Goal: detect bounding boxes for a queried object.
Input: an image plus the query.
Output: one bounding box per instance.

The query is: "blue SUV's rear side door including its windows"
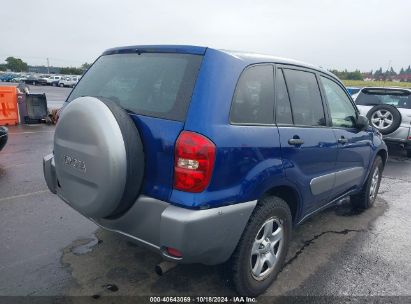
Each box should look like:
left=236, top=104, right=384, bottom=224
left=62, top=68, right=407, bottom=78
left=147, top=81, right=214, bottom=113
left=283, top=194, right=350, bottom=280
left=275, top=66, right=338, bottom=214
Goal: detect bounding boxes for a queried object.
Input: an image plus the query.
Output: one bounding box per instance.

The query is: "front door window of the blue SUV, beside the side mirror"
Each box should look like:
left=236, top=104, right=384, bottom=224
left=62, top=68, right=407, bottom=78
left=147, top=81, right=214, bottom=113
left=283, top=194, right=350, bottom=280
left=321, top=76, right=357, bottom=128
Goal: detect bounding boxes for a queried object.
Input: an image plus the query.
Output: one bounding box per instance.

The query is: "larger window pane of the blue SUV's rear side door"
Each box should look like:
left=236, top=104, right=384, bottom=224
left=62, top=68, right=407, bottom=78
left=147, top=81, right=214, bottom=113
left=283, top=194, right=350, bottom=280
left=284, top=69, right=326, bottom=126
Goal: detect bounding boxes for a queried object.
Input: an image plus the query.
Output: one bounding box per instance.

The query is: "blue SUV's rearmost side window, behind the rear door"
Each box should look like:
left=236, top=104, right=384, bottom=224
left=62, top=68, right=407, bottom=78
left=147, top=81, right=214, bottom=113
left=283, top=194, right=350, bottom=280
left=230, top=65, right=274, bottom=124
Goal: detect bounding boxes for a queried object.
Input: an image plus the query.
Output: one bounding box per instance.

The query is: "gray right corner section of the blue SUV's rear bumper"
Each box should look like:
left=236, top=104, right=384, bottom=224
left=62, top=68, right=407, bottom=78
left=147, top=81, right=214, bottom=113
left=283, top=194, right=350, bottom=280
left=160, top=201, right=257, bottom=265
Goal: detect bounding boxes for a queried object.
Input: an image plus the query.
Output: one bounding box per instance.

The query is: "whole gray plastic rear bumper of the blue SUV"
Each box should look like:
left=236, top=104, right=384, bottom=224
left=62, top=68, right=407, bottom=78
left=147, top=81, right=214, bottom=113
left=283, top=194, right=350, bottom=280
left=43, top=155, right=257, bottom=265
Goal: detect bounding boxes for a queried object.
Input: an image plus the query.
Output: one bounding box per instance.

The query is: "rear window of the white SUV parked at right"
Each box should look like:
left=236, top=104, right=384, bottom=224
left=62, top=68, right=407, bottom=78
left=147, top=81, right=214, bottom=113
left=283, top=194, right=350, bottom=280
left=355, top=89, right=411, bottom=109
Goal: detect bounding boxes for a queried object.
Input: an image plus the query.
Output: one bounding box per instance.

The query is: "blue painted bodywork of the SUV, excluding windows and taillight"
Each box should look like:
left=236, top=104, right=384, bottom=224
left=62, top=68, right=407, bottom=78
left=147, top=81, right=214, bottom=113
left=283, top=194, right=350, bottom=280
left=98, top=46, right=386, bottom=222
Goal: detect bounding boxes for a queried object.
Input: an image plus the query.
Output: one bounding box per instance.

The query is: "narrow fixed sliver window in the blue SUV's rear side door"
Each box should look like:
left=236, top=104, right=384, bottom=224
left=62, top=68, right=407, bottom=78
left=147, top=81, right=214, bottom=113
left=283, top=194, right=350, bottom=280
left=275, top=69, right=293, bottom=125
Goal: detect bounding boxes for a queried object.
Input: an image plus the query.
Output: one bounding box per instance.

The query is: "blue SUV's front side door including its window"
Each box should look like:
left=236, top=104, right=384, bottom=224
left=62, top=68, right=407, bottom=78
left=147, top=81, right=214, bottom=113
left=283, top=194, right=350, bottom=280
left=320, top=75, right=372, bottom=196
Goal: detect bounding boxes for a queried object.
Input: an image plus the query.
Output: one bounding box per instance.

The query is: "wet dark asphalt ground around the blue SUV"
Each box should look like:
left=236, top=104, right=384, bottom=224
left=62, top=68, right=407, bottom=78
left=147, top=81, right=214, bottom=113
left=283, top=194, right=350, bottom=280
left=0, top=110, right=411, bottom=303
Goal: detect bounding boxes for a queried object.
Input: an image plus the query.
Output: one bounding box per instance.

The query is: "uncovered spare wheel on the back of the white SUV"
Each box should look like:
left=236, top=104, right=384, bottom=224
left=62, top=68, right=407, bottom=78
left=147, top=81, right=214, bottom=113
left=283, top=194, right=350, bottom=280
left=367, top=104, right=402, bottom=135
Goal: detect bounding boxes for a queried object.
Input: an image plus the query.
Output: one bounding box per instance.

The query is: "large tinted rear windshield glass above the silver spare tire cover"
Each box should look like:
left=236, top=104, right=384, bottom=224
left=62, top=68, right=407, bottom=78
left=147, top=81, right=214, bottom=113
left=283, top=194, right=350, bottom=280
left=67, top=53, right=202, bottom=121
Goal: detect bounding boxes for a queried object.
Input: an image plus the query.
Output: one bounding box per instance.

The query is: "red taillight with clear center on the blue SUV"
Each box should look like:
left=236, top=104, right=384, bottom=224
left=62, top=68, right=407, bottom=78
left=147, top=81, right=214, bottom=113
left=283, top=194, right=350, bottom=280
left=174, top=131, right=215, bottom=192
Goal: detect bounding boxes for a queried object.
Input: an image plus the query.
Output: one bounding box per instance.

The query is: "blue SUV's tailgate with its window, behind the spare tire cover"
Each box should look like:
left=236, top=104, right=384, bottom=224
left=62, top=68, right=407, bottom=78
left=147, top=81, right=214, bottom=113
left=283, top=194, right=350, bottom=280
left=67, top=47, right=206, bottom=200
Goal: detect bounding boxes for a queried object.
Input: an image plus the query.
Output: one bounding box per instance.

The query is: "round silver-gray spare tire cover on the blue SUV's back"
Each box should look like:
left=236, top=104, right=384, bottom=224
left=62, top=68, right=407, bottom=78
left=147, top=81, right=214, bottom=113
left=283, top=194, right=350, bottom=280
left=54, top=97, right=144, bottom=218
